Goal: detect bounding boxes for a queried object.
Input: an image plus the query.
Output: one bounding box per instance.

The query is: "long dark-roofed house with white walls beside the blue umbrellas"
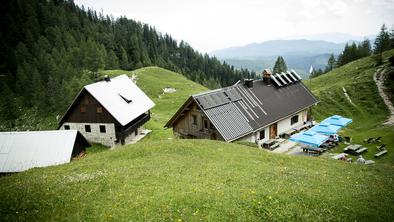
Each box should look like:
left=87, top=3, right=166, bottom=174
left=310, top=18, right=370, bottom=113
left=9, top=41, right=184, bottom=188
left=165, top=70, right=319, bottom=145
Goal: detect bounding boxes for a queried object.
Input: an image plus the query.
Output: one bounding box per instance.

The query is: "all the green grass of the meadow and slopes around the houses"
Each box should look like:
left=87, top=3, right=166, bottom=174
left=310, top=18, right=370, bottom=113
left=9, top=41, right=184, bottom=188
left=0, top=56, right=394, bottom=221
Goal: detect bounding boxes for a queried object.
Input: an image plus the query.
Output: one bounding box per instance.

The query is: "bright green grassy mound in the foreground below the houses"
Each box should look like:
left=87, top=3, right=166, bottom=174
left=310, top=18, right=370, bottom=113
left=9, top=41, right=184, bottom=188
left=0, top=140, right=394, bottom=221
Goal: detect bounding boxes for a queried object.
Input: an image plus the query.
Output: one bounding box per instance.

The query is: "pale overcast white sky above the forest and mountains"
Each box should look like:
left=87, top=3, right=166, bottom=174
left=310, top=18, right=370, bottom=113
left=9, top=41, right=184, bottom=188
left=74, top=0, right=394, bottom=52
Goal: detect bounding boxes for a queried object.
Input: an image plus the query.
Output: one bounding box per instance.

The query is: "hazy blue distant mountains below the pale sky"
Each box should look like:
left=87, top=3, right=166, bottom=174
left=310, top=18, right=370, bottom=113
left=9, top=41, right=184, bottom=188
left=210, top=32, right=375, bottom=74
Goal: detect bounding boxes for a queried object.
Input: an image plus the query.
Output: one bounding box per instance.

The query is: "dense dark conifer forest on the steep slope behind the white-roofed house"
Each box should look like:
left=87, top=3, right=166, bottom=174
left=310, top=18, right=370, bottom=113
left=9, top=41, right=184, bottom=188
left=0, top=0, right=256, bottom=128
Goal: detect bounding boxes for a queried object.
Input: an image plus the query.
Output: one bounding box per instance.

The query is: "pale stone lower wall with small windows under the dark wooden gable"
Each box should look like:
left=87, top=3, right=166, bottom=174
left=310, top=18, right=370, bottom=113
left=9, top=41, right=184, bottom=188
left=60, top=122, right=116, bottom=147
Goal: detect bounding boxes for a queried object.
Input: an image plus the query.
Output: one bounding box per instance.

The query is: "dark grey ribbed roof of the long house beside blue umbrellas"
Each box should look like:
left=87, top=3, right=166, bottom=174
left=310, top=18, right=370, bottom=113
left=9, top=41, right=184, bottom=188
left=166, top=77, right=318, bottom=141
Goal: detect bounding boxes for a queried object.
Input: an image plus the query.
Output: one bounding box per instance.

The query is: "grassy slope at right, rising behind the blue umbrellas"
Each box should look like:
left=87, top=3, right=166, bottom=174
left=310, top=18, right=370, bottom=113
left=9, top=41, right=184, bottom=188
left=305, top=50, right=394, bottom=165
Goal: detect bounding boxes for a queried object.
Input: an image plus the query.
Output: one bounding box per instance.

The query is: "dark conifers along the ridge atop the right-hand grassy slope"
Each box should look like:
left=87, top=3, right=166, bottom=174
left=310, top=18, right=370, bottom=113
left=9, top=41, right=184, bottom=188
left=311, top=24, right=394, bottom=78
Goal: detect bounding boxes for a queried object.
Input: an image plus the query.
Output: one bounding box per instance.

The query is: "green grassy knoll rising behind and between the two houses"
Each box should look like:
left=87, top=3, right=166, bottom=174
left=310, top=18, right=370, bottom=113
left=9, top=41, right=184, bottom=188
left=101, top=67, right=208, bottom=139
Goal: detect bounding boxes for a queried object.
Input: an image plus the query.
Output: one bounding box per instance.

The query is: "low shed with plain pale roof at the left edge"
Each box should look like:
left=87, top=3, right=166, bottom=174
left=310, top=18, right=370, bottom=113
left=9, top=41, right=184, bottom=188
left=0, top=130, right=90, bottom=173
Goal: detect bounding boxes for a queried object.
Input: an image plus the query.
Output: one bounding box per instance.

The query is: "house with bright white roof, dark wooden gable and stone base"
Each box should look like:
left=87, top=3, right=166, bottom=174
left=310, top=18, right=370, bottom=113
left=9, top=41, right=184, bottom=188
left=59, top=75, right=155, bottom=147
